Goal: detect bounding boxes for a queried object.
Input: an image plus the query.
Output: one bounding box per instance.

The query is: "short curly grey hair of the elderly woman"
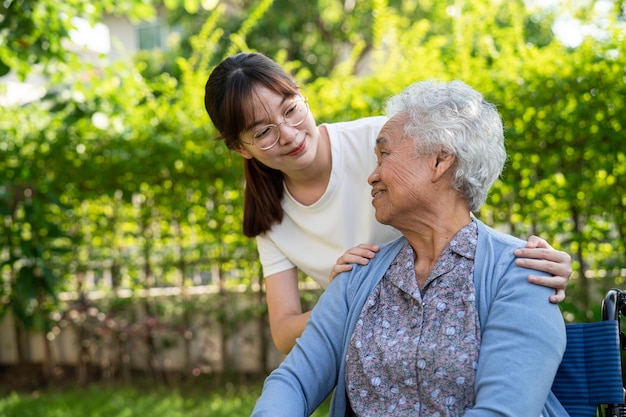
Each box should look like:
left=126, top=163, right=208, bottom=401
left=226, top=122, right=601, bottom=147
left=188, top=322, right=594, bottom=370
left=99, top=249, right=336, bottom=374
left=386, top=80, right=507, bottom=211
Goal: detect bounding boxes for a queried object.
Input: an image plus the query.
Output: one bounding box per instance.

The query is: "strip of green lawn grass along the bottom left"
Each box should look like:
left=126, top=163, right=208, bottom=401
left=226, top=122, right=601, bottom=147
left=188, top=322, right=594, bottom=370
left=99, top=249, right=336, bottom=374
left=0, top=384, right=329, bottom=417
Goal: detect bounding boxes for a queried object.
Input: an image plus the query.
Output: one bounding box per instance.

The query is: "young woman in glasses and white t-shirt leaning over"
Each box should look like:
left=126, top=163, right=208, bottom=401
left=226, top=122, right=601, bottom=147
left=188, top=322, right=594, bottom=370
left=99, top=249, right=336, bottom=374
left=205, top=53, right=571, bottom=353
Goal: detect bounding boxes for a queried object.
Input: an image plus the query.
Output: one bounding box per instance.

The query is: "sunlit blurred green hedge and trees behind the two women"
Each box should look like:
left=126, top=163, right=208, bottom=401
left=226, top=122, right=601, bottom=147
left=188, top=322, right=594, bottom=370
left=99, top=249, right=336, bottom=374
left=0, top=0, right=626, bottom=415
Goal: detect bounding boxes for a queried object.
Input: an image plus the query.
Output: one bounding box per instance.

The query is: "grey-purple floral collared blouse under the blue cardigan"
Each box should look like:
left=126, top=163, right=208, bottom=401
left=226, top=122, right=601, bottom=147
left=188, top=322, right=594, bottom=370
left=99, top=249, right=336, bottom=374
left=346, top=221, right=480, bottom=417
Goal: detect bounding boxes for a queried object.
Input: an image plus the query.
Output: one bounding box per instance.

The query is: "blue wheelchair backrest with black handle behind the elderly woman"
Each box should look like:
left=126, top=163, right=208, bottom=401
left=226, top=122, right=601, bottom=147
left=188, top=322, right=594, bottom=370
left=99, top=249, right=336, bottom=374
left=552, top=288, right=626, bottom=417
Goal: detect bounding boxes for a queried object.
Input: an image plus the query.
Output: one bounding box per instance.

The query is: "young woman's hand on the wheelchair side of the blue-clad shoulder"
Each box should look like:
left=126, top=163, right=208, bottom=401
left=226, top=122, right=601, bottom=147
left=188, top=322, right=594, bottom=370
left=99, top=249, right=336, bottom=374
left=515, top=236, right=572, bottom=303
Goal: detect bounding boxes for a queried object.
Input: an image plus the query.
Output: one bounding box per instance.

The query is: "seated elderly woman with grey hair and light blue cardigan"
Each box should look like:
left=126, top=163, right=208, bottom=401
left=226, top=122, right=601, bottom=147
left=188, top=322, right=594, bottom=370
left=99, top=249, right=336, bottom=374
left=253, top=81, right=567, bottom=417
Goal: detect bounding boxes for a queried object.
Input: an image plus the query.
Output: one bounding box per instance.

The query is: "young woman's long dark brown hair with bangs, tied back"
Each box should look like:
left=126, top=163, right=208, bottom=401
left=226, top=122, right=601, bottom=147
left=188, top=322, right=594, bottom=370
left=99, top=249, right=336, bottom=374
left=204, top=52, right=298, bottom=237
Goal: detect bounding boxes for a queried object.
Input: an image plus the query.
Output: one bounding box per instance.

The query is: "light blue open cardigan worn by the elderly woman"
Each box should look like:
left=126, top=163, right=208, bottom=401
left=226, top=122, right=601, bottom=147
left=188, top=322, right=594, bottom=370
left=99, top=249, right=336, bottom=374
left=252, top=220, right=567, bottom=417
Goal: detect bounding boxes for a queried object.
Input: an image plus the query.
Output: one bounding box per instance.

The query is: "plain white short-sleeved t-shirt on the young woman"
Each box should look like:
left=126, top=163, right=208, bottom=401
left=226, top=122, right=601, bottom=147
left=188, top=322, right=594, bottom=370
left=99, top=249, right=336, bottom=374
left=257, top=116, right=400, bottom=288
